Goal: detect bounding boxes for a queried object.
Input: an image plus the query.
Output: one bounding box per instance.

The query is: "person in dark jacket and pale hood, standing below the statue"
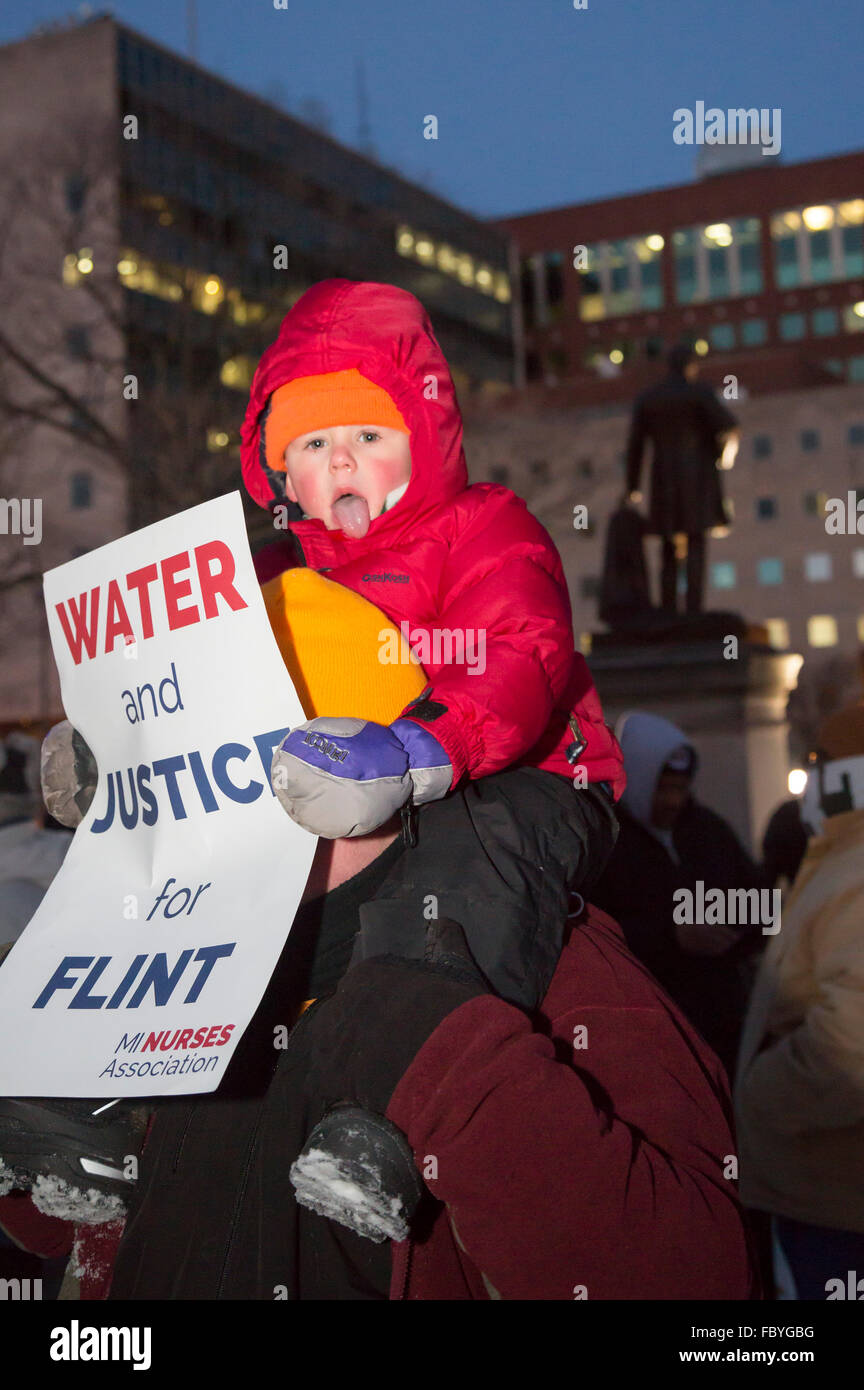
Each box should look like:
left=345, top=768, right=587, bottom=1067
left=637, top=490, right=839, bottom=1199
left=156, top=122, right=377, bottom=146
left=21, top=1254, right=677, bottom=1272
left=590, top=712, right=770, bottom=1076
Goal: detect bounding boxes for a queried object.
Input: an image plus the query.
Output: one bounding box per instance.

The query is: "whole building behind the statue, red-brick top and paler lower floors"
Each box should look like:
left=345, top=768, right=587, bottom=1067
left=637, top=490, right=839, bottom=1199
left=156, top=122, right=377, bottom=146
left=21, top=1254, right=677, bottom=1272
left=467, top=154, right=864, bottom=662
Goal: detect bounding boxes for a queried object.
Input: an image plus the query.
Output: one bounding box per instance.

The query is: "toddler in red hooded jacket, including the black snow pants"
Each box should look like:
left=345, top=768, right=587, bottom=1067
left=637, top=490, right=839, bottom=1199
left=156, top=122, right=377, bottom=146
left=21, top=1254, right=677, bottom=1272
left=242, top=279, right=624, bottom=1006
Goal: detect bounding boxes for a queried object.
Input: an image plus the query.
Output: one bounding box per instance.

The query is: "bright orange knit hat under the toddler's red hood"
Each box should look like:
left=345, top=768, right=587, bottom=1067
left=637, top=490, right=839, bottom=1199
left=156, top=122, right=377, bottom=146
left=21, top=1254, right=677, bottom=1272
left=263, top=367, right=411, bottom=473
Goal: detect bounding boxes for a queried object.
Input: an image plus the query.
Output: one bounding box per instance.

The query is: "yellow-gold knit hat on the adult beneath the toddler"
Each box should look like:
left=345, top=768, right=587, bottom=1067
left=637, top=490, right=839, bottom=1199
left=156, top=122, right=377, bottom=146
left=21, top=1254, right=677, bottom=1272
left=261, top=569, right=428, bottom=724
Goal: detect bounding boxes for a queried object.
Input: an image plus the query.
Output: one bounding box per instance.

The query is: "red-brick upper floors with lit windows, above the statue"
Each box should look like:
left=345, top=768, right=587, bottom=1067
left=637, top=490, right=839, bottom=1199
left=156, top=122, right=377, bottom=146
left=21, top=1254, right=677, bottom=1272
left=499, top=153, right=864, bottom=406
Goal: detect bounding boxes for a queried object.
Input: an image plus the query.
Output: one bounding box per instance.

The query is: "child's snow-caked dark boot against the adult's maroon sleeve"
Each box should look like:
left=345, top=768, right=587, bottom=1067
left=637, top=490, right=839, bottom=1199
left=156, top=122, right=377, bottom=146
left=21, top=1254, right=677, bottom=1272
left=289, top=1105, right=424, bottom=1243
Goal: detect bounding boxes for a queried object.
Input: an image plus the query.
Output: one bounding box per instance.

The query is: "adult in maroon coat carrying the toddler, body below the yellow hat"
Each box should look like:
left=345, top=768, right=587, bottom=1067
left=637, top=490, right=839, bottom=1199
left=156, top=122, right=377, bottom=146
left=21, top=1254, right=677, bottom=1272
left=0, top=644, right=754, bottom=1301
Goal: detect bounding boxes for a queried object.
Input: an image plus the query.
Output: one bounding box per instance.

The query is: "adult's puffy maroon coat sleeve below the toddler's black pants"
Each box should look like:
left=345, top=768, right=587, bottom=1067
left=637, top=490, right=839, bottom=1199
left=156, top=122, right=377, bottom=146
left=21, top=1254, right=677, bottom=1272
left=388, top=917, right=753, bottom=1300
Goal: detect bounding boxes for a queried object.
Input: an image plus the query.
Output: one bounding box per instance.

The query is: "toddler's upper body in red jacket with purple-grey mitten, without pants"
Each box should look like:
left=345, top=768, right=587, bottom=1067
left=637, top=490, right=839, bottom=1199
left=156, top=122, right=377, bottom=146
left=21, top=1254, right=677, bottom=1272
left=243, top=279, right=624, bottom=978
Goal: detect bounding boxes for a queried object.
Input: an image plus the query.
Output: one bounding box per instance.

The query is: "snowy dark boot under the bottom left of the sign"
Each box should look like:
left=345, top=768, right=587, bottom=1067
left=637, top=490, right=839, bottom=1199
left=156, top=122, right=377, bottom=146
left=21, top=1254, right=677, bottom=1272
left=0, top=1098, right=149, bottom=1225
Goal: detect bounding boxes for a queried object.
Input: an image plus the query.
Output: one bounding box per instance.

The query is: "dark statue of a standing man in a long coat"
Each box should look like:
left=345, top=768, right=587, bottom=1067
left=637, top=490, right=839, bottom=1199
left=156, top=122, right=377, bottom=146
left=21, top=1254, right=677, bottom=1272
left=624, top=348, right=739, bottom=613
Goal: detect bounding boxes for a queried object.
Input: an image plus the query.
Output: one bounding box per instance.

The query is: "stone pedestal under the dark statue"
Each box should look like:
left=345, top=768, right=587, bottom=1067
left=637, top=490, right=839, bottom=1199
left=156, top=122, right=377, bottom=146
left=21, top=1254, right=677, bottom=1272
left=589, top=633, right=803, bottom=858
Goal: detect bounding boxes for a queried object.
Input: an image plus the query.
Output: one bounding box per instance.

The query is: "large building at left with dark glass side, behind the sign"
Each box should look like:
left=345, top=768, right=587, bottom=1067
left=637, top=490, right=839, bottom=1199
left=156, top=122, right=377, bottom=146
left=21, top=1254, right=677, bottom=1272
left=0, top=17, right=517, bottom=728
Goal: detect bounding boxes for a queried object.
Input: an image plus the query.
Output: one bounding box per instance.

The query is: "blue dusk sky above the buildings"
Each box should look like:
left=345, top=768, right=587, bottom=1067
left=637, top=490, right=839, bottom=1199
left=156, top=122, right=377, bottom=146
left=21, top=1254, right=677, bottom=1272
left=0, top=0, right=864, bottom=217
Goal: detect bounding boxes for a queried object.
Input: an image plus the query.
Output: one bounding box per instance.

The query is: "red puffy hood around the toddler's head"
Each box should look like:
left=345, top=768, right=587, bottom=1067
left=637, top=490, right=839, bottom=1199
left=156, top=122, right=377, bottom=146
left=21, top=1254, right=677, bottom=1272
left=240, top=279, right=468, bottom=556
